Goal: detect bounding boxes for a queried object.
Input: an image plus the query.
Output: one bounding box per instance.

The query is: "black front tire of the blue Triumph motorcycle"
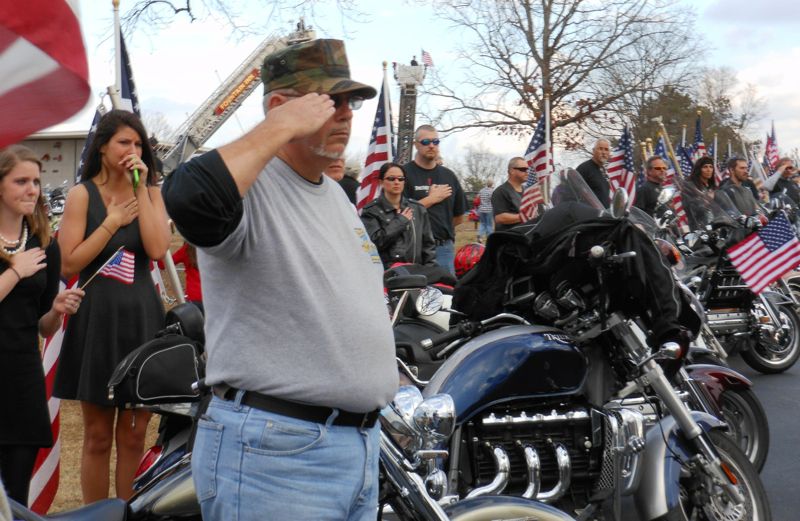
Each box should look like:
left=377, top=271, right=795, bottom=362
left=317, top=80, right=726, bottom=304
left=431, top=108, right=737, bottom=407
left=669, top=431, right=772, bottom=521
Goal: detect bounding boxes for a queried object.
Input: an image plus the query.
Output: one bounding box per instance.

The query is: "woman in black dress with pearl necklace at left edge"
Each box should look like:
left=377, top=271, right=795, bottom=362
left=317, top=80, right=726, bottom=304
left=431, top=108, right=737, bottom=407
left=0, top=145, right=83, bottom=505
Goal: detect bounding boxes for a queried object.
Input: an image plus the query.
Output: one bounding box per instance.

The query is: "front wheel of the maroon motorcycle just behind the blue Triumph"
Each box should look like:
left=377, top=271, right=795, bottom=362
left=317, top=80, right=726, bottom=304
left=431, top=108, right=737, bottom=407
left=719, top=389, right=769, bottom=472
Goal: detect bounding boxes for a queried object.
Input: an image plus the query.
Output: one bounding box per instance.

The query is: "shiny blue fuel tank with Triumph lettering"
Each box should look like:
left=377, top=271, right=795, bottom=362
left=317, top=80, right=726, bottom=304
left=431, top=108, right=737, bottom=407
left=423, top=326, right=587, bottom=423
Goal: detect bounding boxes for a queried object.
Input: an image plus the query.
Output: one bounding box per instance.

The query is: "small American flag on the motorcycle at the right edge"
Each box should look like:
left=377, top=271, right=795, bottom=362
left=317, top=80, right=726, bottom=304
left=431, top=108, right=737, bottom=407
left=728, top=212, right=800, bottom=294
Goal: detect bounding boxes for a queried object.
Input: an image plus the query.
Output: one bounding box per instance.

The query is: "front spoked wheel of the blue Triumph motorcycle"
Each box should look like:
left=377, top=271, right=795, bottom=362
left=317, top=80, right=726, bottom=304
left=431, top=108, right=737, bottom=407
left=678, top=431, right=772, bottom=521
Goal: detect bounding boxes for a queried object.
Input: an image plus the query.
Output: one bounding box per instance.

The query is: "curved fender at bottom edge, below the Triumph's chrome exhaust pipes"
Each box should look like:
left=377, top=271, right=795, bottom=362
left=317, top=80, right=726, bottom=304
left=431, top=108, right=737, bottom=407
left=444, top=496, right=575, bottom=521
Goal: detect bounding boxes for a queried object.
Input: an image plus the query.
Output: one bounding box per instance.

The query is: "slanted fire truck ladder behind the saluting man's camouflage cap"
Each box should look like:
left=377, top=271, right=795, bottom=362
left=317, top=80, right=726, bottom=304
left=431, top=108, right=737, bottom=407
left=155, top=19, right=315, bottom=174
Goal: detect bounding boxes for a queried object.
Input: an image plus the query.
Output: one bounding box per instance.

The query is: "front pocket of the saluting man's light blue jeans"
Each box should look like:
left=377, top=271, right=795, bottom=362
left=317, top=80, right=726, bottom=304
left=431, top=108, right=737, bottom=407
left=244, top=415, right=326, bottom=456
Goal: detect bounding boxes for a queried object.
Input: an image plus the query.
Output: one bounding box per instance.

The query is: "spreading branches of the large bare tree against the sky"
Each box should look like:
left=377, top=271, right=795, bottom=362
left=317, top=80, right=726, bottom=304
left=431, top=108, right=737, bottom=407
left=429, top=0, right=696, bottom=149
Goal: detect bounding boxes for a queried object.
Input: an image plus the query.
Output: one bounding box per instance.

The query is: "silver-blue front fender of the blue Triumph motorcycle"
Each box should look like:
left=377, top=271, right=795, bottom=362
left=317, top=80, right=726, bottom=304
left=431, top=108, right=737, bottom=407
left=633, top=411, right=725, bottom=521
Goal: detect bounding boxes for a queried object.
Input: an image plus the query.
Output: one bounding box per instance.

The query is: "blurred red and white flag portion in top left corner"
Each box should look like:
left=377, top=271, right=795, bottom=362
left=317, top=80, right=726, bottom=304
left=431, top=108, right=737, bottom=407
left=0, top=0, right=90, bottom=148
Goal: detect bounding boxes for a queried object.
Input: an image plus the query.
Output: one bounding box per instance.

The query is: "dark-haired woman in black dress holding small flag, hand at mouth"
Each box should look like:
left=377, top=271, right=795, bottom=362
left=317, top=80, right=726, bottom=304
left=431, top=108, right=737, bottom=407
left=53, top=110, right=171, bottom=503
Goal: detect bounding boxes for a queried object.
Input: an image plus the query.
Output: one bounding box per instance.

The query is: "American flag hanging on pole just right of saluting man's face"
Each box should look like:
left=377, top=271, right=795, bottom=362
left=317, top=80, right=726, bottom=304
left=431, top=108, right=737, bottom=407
left=356, top=76, right=395, bottom=214
